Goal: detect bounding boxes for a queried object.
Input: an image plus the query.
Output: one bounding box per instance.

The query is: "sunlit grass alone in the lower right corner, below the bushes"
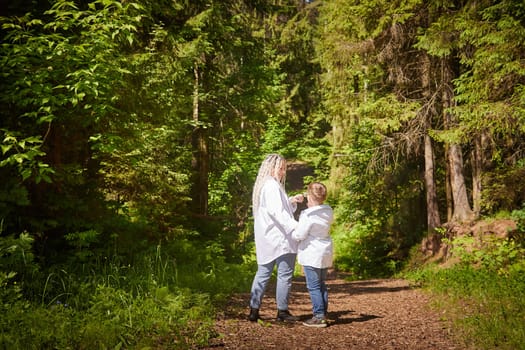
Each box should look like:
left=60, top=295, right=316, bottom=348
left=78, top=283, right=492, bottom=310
left=408, top=266, right=525, bottom=350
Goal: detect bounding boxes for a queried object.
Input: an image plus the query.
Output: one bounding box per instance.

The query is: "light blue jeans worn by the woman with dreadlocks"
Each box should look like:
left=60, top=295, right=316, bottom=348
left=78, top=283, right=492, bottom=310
left=250, top=254, right=296, bottom=310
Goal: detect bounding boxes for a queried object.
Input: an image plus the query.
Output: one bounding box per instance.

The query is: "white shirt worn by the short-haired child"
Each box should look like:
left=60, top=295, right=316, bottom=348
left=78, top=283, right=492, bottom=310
left=293, top=204, right=334, bottom=268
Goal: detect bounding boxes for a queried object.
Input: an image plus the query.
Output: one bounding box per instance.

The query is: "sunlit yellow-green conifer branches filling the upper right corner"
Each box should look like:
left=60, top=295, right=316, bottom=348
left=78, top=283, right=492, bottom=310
left=453, top=0, right=525, bottom=171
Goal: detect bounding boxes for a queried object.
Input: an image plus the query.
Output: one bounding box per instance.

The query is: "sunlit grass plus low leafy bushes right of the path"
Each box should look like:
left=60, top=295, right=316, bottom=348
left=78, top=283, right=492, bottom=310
left=404, top=211, right=525, bottom=350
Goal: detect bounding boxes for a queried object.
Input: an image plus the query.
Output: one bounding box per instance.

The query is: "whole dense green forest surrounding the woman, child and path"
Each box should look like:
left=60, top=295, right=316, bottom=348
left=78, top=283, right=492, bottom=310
left=0, top=0, right=525, bottom=348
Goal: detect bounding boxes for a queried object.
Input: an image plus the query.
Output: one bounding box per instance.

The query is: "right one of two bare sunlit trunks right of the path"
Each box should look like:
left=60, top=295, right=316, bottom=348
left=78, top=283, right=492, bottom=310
left=442, top=59, right=474, bottom=222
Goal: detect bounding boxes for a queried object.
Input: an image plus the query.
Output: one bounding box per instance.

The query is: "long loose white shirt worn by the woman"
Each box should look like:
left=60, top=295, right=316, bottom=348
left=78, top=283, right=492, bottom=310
left=254, top=177, right=297, bottom=265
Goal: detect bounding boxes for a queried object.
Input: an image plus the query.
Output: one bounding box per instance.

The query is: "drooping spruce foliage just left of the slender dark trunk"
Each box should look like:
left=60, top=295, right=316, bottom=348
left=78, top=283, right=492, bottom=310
left=93, top=122, right=190, bottom=237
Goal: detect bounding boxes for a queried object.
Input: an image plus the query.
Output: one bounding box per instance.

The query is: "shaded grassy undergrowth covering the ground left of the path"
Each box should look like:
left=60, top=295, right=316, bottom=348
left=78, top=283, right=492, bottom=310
left=0, top=234, right=251, bottom=350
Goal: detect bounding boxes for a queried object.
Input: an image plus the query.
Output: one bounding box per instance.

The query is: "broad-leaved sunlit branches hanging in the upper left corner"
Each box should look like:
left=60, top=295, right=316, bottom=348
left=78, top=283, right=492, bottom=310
left=0, top=1, right=145, bottom=187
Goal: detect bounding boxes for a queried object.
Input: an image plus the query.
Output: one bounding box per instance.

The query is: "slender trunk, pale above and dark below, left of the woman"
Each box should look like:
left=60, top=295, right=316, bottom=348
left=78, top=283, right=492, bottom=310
left=192, top=63, right=209, bottom=215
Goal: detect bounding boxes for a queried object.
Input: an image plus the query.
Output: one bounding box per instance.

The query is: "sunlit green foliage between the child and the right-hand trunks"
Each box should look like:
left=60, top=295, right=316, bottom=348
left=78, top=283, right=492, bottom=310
left=328, top=113, right=425, bottom=277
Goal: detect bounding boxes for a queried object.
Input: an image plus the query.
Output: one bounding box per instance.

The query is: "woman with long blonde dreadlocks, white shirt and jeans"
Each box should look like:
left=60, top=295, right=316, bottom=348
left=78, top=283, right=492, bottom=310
left=248, top=154, right=304, bottom=322
